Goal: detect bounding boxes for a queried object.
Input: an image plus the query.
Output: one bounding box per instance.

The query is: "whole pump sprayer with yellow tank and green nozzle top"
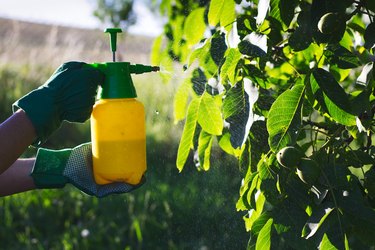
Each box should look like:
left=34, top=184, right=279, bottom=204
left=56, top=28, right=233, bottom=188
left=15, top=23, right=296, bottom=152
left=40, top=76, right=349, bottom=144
left=91, top=28, right=159, bottom=185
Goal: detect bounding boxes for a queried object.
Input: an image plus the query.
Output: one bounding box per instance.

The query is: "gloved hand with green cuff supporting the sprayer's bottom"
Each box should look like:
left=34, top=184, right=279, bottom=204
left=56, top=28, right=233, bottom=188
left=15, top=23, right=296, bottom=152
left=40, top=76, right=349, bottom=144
left=30, top=143, right=145, bottom=197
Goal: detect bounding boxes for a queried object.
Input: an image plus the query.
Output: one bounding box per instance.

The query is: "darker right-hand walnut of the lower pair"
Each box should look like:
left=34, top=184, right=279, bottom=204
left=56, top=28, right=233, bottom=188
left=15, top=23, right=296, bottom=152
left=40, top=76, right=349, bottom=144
left=297, top=158, right=320, bottom=185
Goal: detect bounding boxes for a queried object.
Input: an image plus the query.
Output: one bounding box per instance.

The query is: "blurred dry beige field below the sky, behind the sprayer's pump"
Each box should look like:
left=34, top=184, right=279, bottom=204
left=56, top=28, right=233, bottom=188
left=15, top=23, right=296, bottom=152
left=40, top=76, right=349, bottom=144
left=0, top=18, right=153, bottom=68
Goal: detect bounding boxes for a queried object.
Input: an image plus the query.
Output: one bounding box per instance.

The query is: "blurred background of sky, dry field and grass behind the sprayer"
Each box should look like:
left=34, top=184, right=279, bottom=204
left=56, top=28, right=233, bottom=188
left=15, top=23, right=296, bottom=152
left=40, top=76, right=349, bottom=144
left=0, top=0, right=248, bottom=249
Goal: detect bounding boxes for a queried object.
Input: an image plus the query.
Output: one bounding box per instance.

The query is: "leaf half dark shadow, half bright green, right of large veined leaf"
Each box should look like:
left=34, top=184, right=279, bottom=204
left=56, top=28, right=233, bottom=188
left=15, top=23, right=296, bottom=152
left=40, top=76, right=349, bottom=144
left=310, top=68, right=356, bottom=126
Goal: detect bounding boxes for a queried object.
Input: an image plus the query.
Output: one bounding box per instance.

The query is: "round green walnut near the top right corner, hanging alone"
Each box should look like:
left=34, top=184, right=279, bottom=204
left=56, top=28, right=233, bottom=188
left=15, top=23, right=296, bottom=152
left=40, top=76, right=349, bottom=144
left=318, top=12, right=346, bottom=35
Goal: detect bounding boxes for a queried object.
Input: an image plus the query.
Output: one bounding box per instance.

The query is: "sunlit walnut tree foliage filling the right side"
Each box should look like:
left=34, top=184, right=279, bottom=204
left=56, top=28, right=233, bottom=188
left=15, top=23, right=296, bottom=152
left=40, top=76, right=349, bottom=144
left=152, top=0, right=375, bottom=249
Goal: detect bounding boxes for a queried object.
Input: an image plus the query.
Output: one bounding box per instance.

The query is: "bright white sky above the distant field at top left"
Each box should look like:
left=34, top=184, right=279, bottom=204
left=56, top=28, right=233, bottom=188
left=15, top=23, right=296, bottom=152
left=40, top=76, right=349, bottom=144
left=0, top=0, right=162, bottom=36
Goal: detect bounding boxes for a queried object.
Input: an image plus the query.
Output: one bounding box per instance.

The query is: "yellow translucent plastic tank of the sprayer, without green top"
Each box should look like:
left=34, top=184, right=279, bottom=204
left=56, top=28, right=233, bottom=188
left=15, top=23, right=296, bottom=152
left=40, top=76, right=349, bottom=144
left=91, top=98, right=147, bottom=185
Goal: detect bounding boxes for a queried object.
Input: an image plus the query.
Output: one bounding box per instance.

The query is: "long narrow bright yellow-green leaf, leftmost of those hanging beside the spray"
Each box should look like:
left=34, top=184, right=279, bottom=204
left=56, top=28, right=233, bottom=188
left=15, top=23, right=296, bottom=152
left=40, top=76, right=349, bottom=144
left=176, top=99, right=200, bottom=172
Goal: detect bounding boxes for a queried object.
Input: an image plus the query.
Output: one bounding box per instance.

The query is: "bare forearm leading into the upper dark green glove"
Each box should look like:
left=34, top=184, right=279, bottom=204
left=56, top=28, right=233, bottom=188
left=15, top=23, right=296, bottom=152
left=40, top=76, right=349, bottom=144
left=0, top=110, right=36, bottom=175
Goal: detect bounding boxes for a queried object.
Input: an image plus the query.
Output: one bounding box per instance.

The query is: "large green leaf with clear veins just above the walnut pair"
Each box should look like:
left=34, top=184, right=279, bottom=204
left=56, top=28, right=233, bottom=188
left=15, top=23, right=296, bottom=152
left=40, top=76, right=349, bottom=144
left=267, top=84, right=305, bottom=152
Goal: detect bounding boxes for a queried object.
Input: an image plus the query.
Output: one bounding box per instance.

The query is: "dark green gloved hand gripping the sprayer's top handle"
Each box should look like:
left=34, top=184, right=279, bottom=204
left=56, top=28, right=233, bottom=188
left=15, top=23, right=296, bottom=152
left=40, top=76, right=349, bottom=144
left=13, top=62, right=104, bottom=145
